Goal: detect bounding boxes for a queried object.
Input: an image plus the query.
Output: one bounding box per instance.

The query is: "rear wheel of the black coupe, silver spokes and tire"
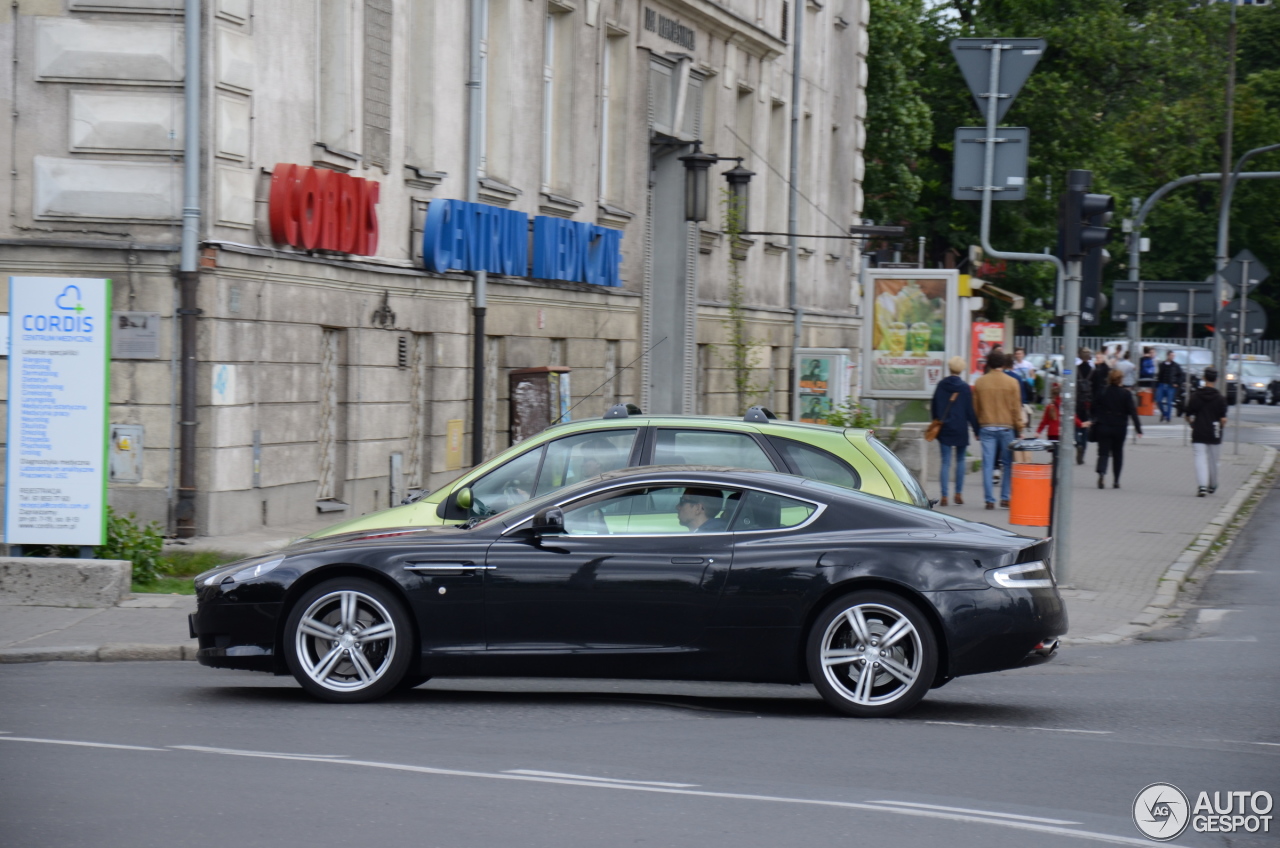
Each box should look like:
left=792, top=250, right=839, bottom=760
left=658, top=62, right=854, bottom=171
left=805, top=591, right=938, bottom=719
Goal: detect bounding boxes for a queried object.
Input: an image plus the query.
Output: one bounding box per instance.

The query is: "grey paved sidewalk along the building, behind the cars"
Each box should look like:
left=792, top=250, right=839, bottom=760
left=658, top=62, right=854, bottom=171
left=0, top=432, right=1276, bottom=662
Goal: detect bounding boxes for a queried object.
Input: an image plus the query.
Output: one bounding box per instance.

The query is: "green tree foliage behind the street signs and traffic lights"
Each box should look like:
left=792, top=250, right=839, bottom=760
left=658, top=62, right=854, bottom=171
left=865, top=0, right=1280, bottom=334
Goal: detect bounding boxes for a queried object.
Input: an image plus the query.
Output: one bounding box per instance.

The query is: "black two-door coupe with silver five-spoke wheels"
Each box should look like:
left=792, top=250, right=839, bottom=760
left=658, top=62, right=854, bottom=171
left=191, top=466, right=1068, bottom=717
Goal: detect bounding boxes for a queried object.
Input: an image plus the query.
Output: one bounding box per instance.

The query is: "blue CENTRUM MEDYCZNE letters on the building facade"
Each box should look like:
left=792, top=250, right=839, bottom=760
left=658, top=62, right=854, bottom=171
left=422, top=199, right=622, bottom=287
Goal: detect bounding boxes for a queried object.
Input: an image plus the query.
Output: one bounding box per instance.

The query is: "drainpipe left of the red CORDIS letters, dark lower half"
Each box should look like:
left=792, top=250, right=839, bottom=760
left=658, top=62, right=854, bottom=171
left=174, top=0, right=201, bottom=539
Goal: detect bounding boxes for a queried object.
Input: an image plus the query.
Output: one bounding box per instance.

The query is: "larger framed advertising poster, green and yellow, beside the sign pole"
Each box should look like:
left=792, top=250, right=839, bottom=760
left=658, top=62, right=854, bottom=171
left=867, top=270, right=957, bottom=397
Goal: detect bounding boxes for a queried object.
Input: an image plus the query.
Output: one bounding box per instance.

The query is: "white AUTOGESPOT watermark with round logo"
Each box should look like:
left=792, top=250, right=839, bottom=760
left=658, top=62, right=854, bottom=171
left=1133, top=783, right=1272, bottom=842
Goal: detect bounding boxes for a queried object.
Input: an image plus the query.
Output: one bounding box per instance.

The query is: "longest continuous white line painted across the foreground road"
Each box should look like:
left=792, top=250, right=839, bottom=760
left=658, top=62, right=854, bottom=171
left=172, top=746, right=1151, bottom=847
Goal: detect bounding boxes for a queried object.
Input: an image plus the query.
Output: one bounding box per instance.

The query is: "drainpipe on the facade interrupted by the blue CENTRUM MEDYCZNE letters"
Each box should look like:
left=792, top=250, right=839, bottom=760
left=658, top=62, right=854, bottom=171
left=466, top=0, right=489, bottom=466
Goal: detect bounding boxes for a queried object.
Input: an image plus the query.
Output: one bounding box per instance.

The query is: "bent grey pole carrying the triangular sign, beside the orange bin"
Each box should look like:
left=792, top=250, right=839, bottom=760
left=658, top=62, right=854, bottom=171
left=979, top=42, right=1080, bottom=585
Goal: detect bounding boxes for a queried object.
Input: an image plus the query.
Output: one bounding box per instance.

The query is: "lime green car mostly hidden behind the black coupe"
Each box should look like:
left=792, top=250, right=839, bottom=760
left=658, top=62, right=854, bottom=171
left=305, top=404, right=929, bottom=539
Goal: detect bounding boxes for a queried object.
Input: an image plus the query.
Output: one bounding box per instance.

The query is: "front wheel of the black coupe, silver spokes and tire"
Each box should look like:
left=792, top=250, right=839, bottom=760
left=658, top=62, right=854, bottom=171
left=284, top=578, right=417, bottom=703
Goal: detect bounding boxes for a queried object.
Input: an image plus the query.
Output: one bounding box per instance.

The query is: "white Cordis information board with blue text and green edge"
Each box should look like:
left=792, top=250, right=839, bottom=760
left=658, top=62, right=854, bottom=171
left=4, top=277, right=111, bottom=546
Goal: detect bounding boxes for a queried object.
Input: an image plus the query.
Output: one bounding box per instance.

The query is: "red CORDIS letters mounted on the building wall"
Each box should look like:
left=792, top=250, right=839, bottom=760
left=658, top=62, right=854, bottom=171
left=269, top=163, right=380, bottom=256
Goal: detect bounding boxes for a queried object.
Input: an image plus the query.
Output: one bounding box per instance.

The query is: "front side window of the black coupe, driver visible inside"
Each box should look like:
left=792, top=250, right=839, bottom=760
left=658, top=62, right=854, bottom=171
left=564, top=485, right=742, bottom=535
